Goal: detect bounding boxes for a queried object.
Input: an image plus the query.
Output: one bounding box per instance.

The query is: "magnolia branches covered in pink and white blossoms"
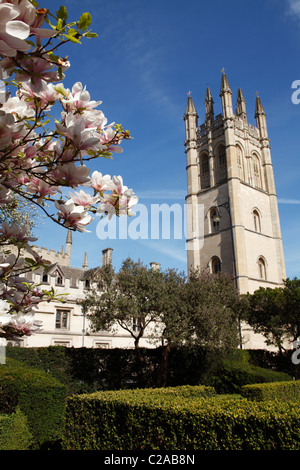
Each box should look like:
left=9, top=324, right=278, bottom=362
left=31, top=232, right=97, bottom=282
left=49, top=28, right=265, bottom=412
left=0, top=0, right=137, bottom=339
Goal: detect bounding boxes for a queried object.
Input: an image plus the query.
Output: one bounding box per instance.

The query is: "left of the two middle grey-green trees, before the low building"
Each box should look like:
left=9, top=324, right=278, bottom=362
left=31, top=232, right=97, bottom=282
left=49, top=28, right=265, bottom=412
left=83, top=258, right=162, bottom=351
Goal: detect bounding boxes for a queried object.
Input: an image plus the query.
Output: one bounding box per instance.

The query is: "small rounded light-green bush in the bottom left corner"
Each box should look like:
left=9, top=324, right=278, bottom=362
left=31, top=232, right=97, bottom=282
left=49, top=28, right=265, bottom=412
left=0, top=408, right=32, bottom=450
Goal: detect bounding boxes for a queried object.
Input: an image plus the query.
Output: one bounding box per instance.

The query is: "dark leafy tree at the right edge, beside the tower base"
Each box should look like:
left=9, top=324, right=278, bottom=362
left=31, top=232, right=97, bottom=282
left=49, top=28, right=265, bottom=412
left=247, top=278, right=300, bottom=353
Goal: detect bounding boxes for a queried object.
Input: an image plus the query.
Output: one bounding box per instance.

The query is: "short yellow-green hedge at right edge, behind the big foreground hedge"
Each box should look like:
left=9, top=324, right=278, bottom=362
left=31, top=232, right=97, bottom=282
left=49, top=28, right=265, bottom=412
left=241, top=380, right=300, bottom=403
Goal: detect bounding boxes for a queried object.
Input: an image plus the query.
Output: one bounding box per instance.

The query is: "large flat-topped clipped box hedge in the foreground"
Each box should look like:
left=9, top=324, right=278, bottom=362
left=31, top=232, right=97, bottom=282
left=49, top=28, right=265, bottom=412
left=63, top=389, right=300, bottom=451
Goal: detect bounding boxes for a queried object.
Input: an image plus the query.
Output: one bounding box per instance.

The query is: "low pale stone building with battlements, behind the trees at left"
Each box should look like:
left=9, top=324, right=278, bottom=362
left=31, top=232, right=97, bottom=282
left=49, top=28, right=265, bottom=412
left=8, top=230, right=157, bottom=349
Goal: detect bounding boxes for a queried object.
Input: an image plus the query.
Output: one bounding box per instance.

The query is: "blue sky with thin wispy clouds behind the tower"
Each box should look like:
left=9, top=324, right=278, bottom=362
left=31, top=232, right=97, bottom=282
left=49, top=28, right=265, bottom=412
left=35, top=0, right=300, bottom=277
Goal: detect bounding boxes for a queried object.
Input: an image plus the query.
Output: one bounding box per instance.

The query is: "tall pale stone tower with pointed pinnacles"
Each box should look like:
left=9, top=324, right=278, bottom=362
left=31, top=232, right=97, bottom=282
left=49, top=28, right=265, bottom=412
left=184, top=73, right=286, bottom=293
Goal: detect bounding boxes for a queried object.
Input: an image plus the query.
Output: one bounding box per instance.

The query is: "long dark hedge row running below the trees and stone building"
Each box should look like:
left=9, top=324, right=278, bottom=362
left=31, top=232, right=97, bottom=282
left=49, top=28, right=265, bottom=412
left=6, top=346, right=292, bottom=395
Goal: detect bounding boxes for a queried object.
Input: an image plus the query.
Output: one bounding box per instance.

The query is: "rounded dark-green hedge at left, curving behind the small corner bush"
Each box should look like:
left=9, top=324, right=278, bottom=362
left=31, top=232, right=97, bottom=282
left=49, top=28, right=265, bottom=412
left=0, top=358, right=66, bottom=447
